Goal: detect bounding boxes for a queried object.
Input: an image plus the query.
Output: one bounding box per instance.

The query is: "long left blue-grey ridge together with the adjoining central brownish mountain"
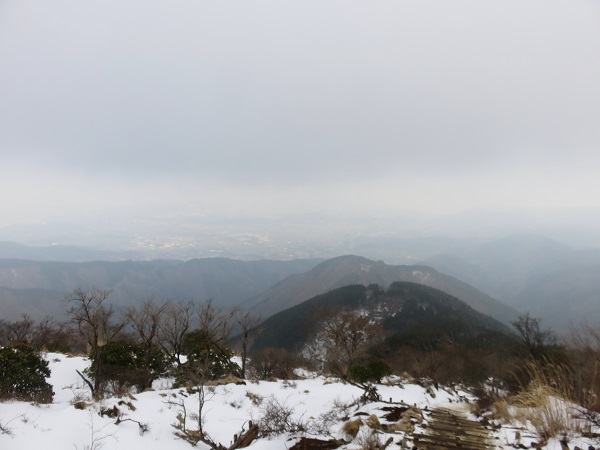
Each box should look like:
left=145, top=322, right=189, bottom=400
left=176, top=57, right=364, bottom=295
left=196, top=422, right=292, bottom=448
left=0, top=251, right=517, bottom=323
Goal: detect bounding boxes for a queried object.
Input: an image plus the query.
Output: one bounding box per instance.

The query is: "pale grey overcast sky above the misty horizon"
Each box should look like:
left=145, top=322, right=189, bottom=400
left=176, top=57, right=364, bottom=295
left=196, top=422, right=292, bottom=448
left=0, top=0, right=600, bottom=226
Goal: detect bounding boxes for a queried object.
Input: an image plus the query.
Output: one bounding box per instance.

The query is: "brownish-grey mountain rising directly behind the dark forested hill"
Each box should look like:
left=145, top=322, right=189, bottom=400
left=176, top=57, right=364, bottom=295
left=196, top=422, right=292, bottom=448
left=242, top=255, right=518, bottom=323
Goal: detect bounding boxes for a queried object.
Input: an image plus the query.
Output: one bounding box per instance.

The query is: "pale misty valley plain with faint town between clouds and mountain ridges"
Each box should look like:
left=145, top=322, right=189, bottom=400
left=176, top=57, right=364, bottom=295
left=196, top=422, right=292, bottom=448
left=0, top=205, right=600, bottom=264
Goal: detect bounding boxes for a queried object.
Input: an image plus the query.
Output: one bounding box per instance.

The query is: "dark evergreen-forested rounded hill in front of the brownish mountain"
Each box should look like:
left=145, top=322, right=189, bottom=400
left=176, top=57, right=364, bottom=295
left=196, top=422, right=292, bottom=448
left=252, top=282, right=508, bottom=352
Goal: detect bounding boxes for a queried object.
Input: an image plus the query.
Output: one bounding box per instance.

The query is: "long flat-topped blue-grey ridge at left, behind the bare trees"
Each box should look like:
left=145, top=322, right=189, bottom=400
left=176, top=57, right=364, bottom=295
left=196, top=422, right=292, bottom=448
left=0, top=258, right=320, bottom=319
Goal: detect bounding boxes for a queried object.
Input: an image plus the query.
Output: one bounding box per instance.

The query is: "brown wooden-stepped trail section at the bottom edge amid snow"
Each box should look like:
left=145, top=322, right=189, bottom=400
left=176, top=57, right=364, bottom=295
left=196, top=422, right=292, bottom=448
left=413, top=408, right=496, bottom=450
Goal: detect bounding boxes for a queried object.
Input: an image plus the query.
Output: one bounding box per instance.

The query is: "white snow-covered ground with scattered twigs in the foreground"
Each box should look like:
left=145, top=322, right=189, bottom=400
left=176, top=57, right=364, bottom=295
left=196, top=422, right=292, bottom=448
left=0, top=353, right=592, bottom=450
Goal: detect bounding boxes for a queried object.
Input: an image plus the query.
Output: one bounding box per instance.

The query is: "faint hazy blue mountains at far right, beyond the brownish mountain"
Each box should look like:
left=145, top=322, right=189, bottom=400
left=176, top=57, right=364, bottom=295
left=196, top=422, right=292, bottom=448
left=423, top=234, right=600, bottom=328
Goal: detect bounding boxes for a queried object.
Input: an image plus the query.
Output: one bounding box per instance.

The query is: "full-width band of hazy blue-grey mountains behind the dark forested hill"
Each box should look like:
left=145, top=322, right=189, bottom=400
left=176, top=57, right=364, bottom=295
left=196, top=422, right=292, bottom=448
left=0, top=230, right=600, bottom=329
